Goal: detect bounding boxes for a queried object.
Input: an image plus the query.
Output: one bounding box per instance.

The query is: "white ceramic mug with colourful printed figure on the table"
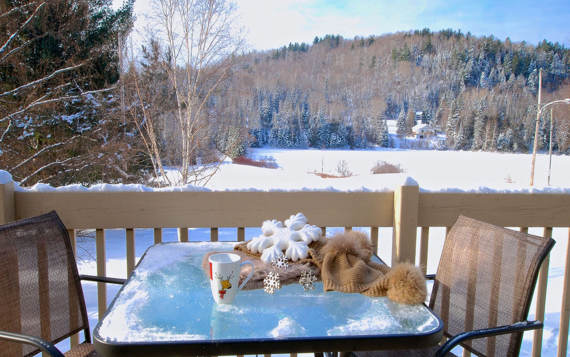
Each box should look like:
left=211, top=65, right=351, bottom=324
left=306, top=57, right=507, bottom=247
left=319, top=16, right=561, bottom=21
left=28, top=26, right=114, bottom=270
left=208, top=253, right=254, bottom=304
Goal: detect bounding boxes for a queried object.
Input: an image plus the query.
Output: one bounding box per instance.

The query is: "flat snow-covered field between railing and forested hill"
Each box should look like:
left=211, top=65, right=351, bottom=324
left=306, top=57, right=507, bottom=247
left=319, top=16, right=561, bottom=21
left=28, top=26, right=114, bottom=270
left=207, top=149, right=570, bottom=192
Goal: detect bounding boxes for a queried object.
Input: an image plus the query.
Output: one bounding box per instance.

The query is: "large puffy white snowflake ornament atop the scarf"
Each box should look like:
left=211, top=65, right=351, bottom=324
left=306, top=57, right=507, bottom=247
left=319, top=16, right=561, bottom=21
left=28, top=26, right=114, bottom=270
left=247, top=213, right=322, bottom=263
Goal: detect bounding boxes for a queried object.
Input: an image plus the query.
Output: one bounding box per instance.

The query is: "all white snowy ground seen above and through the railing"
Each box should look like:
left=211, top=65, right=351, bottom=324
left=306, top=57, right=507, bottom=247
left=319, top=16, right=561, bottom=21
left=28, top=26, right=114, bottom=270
left=33, top=148, right=570, bottom=356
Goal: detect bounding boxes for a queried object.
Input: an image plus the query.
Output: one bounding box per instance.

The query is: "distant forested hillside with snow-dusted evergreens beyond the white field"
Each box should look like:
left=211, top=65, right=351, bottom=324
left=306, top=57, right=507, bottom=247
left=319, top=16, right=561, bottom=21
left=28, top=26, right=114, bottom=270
left=214, top=29, right=570, bottom=153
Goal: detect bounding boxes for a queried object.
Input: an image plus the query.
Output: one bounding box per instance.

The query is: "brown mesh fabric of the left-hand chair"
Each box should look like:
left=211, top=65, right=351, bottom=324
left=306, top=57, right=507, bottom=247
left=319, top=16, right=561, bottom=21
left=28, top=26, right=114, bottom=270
left=0, top=212, right=90, bottom=356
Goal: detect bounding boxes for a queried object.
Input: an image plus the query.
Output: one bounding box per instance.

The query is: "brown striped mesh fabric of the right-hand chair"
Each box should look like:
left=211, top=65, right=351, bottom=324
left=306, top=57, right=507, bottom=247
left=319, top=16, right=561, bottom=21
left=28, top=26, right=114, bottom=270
left=430, top=216, right=554, bottom=356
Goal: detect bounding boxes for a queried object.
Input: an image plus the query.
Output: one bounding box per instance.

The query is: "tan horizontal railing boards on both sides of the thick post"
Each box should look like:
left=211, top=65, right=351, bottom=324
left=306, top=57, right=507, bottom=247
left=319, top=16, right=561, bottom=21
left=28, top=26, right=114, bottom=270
left=5, top=186, right=570, bottom=229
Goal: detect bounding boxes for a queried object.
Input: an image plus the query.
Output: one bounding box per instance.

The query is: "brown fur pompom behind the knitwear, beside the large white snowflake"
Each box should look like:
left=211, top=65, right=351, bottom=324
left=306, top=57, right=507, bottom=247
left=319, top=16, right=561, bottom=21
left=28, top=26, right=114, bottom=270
left=321, top=231, right=372, bottom=261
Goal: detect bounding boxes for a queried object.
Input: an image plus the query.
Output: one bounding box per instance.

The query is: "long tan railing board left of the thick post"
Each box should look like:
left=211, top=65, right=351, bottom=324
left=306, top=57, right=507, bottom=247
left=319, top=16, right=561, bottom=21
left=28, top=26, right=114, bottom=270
left=15, top=191, right=394, bottom=229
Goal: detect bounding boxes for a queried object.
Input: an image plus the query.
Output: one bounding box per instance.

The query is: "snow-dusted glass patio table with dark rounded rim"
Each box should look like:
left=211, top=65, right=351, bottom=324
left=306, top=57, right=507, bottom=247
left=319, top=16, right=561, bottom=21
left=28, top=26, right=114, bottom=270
left=94, top=242, right=442, bottom=356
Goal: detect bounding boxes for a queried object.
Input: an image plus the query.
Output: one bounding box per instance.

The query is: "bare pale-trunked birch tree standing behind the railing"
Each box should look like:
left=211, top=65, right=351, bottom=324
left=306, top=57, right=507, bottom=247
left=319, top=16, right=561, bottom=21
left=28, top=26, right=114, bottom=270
left=153, top=0, right=243, bottom=184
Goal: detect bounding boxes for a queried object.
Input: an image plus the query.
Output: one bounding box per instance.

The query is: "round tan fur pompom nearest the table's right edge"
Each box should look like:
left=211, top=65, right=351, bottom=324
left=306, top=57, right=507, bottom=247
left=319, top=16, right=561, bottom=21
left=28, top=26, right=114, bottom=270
left=385, top=263, right=427, bottom=304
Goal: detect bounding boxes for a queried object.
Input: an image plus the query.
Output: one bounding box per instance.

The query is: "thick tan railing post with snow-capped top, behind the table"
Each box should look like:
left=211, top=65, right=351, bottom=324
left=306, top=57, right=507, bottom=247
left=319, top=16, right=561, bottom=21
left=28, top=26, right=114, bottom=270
left=392, top=179, right=420, bottom=265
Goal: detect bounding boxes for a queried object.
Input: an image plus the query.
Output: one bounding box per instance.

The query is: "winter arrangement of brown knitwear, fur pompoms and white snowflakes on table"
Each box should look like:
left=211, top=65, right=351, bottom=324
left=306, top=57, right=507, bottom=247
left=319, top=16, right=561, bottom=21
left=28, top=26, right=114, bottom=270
left=202, top=213, right=427, bottom=304
